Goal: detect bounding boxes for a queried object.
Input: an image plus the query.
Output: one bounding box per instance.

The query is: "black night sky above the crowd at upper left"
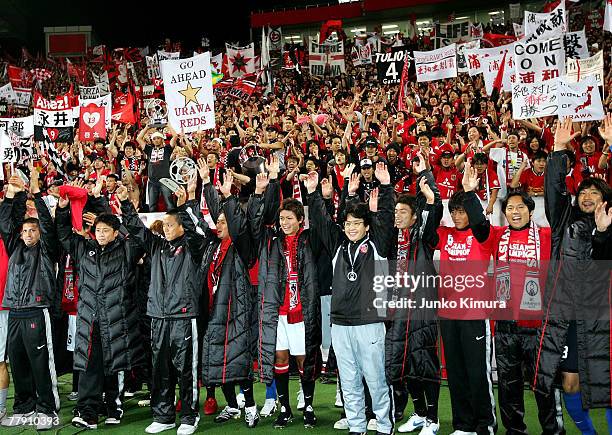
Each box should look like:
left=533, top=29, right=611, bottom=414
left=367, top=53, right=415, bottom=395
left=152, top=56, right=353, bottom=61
left=0, top=0, right=330, bottom=55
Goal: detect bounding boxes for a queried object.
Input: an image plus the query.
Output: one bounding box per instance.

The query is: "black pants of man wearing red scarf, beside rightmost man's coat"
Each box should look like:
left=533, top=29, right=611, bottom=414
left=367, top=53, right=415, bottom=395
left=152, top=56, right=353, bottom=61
left=495, top=321, right=565, bottom=435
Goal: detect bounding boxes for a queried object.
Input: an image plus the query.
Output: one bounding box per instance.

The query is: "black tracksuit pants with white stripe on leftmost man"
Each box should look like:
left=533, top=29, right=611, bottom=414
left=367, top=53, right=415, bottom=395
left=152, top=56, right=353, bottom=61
left=7, top=308, right=60, bottom=415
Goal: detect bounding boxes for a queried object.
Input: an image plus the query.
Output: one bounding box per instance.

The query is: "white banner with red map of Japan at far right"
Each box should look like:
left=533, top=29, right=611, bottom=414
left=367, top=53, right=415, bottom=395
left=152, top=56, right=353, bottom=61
left=557, top=76, right=604, bottom=122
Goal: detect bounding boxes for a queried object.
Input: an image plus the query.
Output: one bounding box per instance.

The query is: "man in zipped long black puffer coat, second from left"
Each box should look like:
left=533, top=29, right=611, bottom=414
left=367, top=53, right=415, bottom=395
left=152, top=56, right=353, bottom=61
left=55, top=190, right=144, bottom=429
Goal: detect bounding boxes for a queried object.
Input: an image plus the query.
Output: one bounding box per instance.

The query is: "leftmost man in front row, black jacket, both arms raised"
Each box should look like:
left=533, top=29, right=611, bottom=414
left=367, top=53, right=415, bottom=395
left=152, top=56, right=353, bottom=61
left=0, top=174, right=60, bottom=429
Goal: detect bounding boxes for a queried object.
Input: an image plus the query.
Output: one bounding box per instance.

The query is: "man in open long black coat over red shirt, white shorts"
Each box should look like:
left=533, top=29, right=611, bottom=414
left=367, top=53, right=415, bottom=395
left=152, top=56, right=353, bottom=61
left=247, top=158, right=322, bottom=428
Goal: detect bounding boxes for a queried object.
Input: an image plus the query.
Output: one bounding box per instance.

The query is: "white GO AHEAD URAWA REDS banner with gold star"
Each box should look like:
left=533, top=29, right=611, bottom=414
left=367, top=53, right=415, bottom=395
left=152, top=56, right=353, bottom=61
left=162, top=52, right=215, bottom=133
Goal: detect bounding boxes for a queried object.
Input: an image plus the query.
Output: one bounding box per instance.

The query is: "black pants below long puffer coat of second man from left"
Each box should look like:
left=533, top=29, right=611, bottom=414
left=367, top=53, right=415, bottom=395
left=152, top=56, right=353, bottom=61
left=77, top=322, right=124, bottom=422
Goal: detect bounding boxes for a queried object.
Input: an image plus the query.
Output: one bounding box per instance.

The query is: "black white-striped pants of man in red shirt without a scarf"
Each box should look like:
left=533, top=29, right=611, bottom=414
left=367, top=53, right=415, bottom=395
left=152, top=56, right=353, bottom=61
left=440, top=320, right=497, bottom=435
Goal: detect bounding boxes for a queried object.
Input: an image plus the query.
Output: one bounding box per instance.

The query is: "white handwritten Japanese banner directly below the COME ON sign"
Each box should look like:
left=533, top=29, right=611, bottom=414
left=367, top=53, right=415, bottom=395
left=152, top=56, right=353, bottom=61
left=512, top=79, right=558, bottom=119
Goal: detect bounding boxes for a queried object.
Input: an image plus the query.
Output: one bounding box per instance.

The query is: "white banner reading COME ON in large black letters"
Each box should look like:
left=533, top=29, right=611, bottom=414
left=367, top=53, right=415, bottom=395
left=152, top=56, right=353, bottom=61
left=514, top=35, right=565, bottom=83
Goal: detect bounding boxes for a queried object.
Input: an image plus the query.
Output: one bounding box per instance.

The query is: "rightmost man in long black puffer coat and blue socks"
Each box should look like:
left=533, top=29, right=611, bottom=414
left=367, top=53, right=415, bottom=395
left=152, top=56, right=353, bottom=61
left=534, top=115, right=612, bottom=433
